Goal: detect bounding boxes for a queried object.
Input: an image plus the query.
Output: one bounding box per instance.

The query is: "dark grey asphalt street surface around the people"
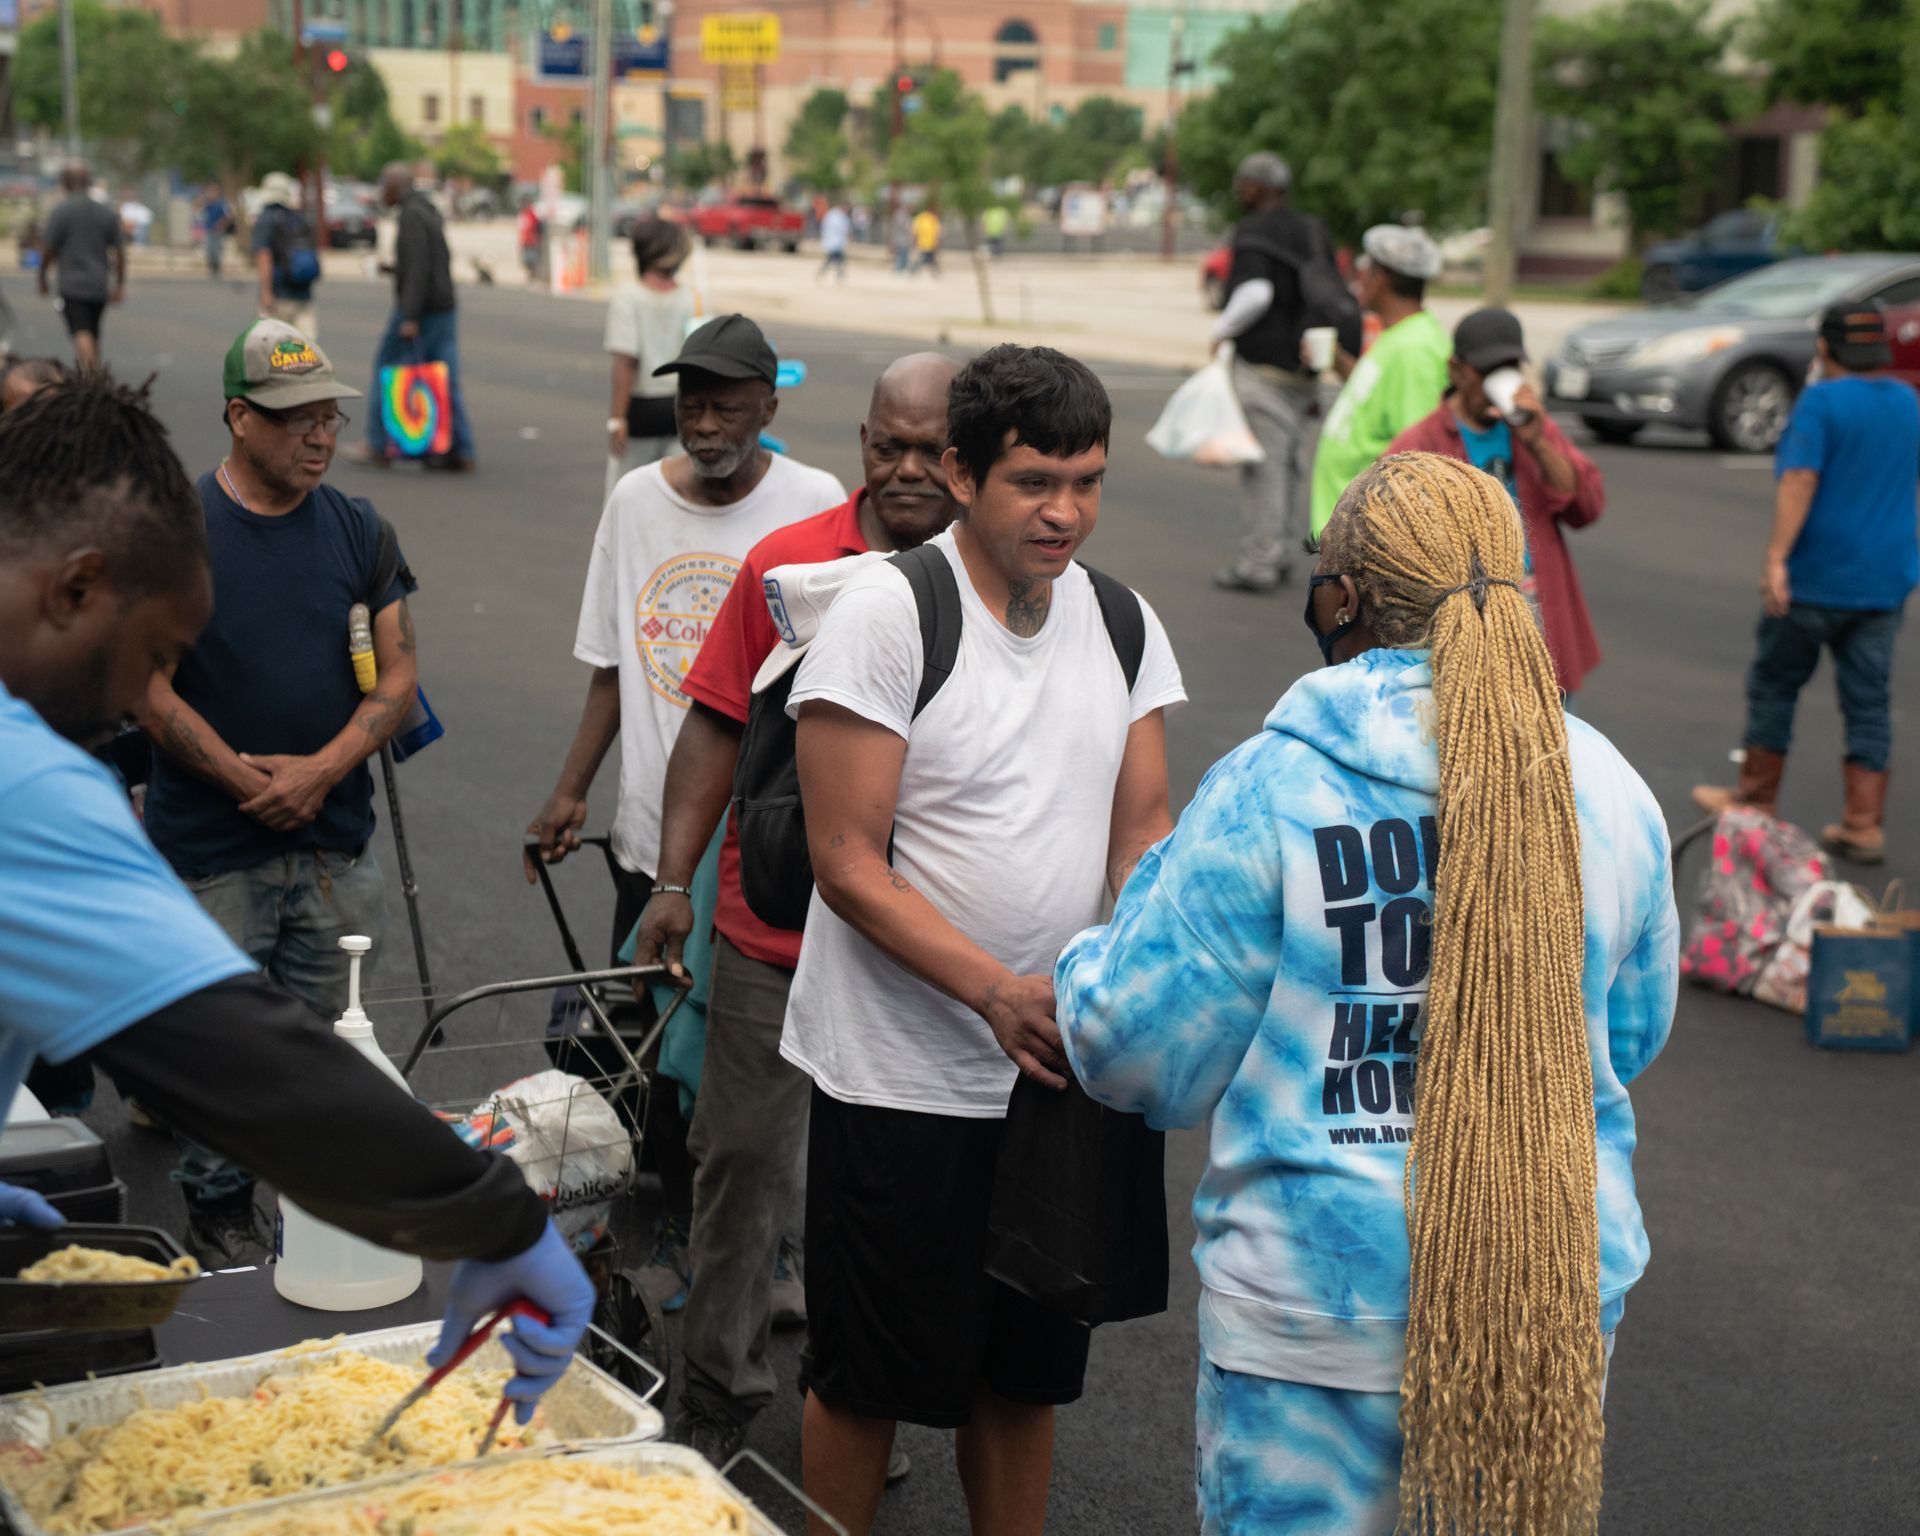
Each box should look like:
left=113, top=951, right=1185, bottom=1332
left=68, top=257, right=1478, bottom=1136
left=10, top=278, right=1920, bottom=1536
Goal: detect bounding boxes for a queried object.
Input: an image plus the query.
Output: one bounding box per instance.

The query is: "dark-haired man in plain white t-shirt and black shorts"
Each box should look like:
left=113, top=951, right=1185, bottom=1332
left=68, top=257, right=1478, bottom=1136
left=781, top=346, right=1187, bottom=1536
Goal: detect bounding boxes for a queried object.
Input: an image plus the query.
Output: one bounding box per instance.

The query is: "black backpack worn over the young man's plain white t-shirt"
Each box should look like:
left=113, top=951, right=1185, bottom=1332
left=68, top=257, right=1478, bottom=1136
left=733, top=545, right=1146, bottom=929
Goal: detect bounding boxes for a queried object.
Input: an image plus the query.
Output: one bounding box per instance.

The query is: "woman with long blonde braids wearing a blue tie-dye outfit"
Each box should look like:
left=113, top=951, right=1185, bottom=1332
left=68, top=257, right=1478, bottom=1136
left=1056, top=453, right=1678, bottom=1536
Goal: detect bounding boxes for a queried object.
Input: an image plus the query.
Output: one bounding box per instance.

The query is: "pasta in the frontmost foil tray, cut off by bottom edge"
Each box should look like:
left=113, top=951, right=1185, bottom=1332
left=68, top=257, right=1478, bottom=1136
left=221, top=1461, right=749, bottom=1536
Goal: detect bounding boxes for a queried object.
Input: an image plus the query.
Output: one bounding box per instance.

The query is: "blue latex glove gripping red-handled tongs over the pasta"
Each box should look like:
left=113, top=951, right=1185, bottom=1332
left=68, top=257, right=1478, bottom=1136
left=426, top=1221, right=593, bottom=1425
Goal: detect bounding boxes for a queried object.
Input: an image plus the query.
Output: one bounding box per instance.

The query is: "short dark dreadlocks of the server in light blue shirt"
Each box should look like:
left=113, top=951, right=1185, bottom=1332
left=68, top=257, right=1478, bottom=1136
left=0, top=369, right=207, bottom=599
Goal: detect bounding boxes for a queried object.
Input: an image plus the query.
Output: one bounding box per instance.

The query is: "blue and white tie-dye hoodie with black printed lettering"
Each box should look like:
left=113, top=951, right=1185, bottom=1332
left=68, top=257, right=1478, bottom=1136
left=1054, top=651, right=1678, bottom=1392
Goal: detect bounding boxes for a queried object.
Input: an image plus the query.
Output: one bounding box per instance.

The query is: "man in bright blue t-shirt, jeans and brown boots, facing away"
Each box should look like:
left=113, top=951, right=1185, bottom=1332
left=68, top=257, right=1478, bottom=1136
left=1693, top=301, right=1920, bottom=864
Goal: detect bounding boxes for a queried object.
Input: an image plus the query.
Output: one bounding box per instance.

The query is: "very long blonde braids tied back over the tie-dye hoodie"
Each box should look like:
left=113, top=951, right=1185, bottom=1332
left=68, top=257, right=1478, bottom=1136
left=1327, top=453, right=1605, bottom=1536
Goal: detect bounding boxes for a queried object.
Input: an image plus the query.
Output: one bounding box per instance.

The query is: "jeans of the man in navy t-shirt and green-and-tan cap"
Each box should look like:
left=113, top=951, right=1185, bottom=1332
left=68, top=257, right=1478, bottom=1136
left=173, top=847, right=386, bottom=1200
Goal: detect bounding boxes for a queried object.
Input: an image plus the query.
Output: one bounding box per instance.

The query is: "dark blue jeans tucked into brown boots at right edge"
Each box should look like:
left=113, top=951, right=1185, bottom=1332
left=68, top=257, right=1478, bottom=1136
left=1747, top=603, right=1903, bottom=774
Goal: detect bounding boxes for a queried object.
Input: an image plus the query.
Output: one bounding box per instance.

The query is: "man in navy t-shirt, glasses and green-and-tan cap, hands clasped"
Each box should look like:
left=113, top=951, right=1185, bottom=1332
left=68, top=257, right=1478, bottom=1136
left=142, top=321, right=415, bottom=1265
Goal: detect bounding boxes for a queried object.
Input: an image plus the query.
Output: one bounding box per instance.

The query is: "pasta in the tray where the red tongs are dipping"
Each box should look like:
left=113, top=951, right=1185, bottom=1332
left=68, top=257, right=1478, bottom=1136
left=0, top=1350, right=540, bottom=1536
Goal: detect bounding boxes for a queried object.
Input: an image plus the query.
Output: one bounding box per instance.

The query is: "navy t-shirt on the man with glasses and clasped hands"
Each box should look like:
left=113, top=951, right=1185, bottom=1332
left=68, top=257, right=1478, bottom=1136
left=146, top=472, right=415, bottom=877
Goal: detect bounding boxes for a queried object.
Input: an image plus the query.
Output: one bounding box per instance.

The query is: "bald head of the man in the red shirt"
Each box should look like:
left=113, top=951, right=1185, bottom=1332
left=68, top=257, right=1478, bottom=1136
left=860, top=351, right=960, bottom=549
